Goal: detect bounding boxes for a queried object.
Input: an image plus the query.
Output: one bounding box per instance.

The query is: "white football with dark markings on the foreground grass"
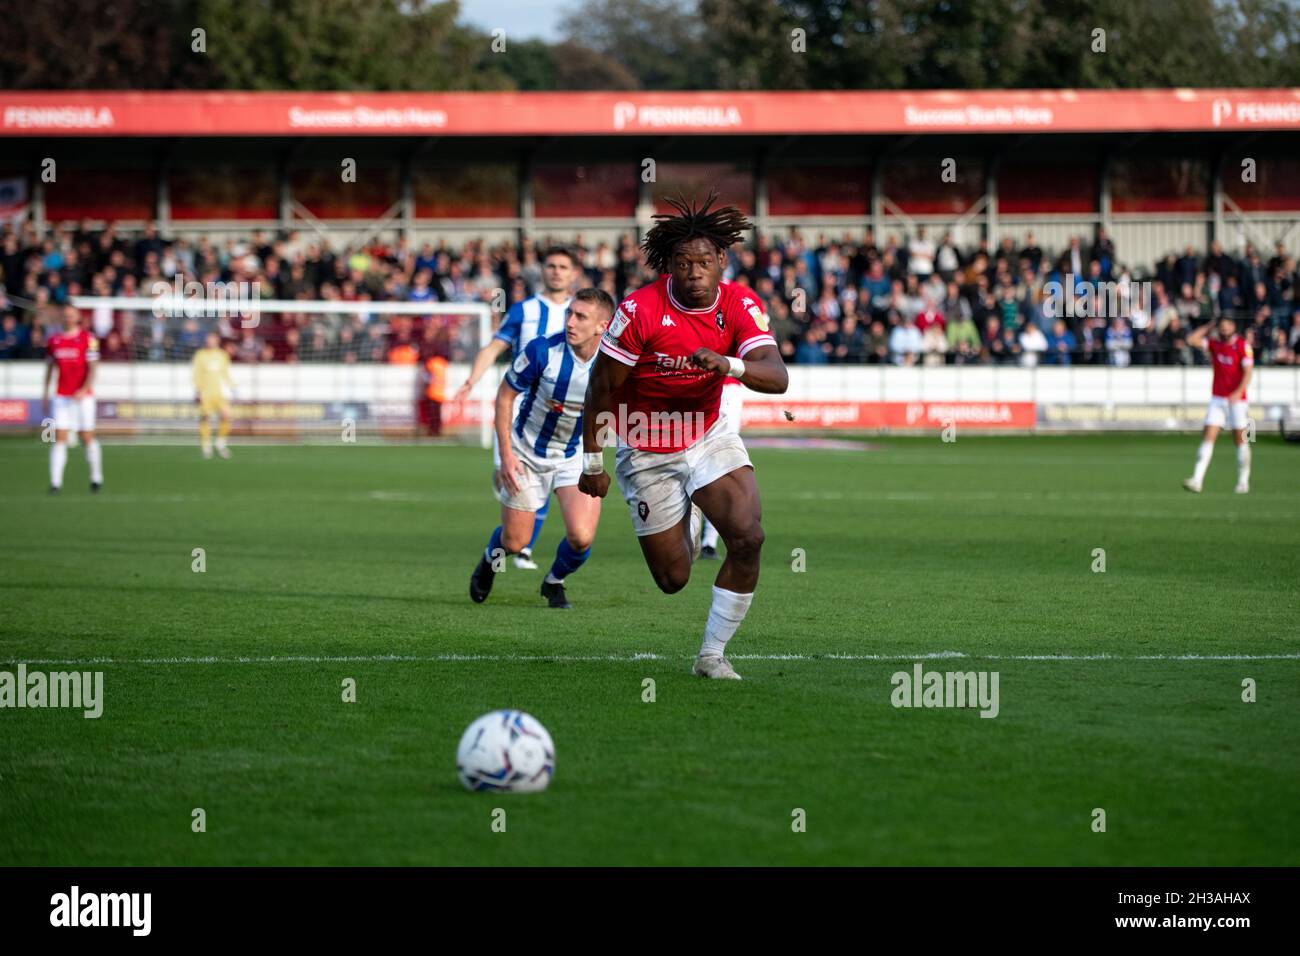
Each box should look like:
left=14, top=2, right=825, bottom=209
left=456, top=710, right=555, bottom=793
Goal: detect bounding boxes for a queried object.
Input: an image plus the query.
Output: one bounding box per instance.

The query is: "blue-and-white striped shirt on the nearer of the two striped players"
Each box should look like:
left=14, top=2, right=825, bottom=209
left=506, top=332, right=595, bottom=459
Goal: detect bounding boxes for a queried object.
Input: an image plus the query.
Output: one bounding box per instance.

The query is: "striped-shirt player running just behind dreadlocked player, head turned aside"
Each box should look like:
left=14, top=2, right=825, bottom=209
left=469, top=289, right=614, bottom=607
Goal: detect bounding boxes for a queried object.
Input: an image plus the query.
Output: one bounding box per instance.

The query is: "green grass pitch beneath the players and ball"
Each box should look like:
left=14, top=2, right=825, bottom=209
left=0, top=434, right=1300, bottom=865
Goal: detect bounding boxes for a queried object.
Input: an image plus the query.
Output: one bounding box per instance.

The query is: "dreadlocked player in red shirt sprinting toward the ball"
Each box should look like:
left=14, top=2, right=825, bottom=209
left=579, top=191, right=789, bottom=680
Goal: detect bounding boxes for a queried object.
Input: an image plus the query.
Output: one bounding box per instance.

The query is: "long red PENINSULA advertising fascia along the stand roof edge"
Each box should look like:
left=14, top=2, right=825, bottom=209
left=0, top=88, right=1300, bottom=137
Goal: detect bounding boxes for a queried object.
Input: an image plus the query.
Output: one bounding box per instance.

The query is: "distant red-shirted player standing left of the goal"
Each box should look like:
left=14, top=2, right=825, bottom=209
left=42, top=306, right=104, bottom=494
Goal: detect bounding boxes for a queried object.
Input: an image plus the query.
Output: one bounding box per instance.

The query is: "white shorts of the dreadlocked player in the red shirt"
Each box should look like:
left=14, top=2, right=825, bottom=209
left=614, top=418, right=753, bottom=537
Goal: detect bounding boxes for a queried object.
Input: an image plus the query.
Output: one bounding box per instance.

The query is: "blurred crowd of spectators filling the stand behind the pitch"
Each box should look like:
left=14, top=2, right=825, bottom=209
left=0, top=222, right=1300, bottom=365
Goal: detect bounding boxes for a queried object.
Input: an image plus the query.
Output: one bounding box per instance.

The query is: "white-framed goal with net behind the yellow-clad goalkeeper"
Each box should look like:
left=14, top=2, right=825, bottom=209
left=72, top=294, right=506, bottom=446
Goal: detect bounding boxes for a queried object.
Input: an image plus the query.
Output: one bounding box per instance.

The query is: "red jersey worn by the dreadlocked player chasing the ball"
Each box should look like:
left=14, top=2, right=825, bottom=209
left=601, top=276, right=776, bottom=453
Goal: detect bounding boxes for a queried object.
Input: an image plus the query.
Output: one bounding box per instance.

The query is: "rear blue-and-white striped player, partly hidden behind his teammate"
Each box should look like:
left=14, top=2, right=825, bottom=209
left=455, top=246, right=580, bottom=570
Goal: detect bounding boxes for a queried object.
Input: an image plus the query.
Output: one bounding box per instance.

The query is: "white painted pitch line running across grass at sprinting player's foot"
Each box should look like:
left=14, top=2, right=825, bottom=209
left=3, top=650, right=1300, bottom=667
